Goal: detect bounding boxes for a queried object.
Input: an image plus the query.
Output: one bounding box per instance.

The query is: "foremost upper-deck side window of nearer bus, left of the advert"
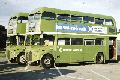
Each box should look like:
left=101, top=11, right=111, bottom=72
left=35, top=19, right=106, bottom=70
left=42, top=11, right=56, bottom=20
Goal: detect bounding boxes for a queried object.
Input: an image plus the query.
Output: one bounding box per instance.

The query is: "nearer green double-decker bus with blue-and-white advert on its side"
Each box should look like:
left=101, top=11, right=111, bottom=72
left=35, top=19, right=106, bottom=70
left=11, top=7, right=117, bottom=68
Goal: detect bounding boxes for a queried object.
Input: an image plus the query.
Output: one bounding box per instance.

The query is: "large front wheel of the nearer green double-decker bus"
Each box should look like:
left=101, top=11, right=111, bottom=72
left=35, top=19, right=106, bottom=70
left=41, top=54, right=54, bottom=69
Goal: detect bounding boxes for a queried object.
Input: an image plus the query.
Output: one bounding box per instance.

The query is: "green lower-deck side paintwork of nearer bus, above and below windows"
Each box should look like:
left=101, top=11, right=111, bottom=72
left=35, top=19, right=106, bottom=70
left=56, top=35, right=109, bottom=63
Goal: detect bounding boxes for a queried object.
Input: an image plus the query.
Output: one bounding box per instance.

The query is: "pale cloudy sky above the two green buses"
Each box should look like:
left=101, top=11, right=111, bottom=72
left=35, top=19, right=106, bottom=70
left=0, top=0, right=120, bottom=38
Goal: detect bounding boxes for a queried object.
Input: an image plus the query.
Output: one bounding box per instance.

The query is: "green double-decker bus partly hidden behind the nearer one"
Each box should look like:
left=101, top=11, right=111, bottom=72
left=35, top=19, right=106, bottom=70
left=6, top=13, right=29, bottom=64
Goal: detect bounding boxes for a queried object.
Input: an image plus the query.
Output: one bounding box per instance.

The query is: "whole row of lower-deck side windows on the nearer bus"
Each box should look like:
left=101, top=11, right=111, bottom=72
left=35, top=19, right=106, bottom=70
left=58, top=38, right=103, bottom=45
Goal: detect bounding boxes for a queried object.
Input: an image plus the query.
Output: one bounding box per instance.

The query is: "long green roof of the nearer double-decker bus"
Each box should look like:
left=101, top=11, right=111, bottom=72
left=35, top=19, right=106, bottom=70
left=31, top=7, right=114, bottom=20
